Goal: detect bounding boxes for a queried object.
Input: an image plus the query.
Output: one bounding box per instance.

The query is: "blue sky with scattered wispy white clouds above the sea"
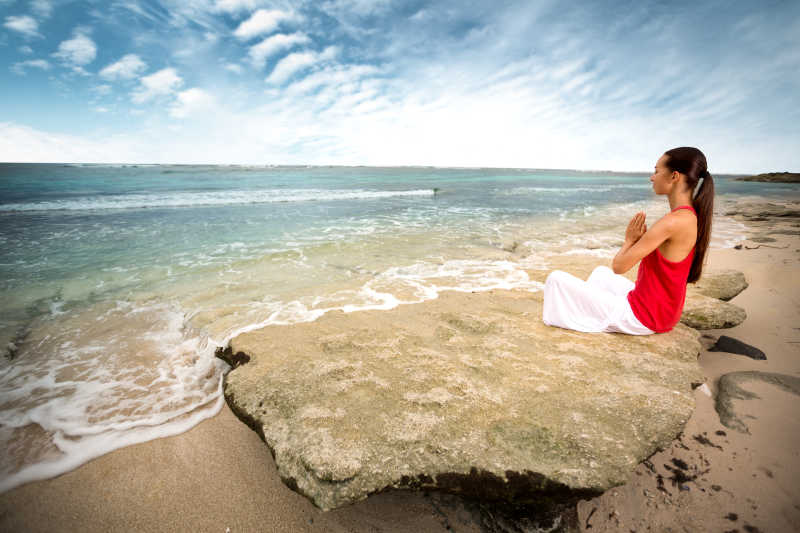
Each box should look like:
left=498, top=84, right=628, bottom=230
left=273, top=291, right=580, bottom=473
left=0, top=0, right=800, bottom=170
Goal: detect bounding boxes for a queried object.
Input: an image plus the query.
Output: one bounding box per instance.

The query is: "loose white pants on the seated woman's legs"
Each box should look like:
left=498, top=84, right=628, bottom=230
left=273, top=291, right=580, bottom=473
left=542, top=266, right=655, bottom=335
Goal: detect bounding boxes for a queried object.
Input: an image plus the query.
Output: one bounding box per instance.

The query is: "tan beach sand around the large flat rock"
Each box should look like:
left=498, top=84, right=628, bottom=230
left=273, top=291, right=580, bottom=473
left=0, top=213, right=800, bottom=533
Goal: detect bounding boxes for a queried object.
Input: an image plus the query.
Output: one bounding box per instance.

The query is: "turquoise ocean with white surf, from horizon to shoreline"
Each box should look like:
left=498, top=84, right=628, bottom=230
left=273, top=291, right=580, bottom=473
left=0, top=164, right=793, bottom=492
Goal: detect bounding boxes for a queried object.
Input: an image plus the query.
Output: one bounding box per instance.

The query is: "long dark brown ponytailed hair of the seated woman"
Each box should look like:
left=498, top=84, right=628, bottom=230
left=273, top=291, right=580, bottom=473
left=664, top=146, right=714, bottom=283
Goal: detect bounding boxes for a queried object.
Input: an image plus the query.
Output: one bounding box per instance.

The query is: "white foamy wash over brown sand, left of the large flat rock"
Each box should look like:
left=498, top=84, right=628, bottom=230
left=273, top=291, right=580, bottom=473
left=0, top=301, right=226, bottom=492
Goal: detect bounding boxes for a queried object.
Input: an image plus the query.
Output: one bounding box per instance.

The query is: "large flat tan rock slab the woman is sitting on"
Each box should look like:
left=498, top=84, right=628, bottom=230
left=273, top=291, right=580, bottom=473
left=224, top=291, right=702, bottom=509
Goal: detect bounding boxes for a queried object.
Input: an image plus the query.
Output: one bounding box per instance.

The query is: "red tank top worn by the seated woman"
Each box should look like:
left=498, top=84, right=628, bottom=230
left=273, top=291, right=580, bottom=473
left=628, top=205, right=697, bottom=333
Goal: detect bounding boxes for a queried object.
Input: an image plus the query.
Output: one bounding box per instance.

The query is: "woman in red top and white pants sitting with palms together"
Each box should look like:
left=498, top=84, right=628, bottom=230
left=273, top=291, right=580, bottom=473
left=542, top=147, right=714, bottom=335
